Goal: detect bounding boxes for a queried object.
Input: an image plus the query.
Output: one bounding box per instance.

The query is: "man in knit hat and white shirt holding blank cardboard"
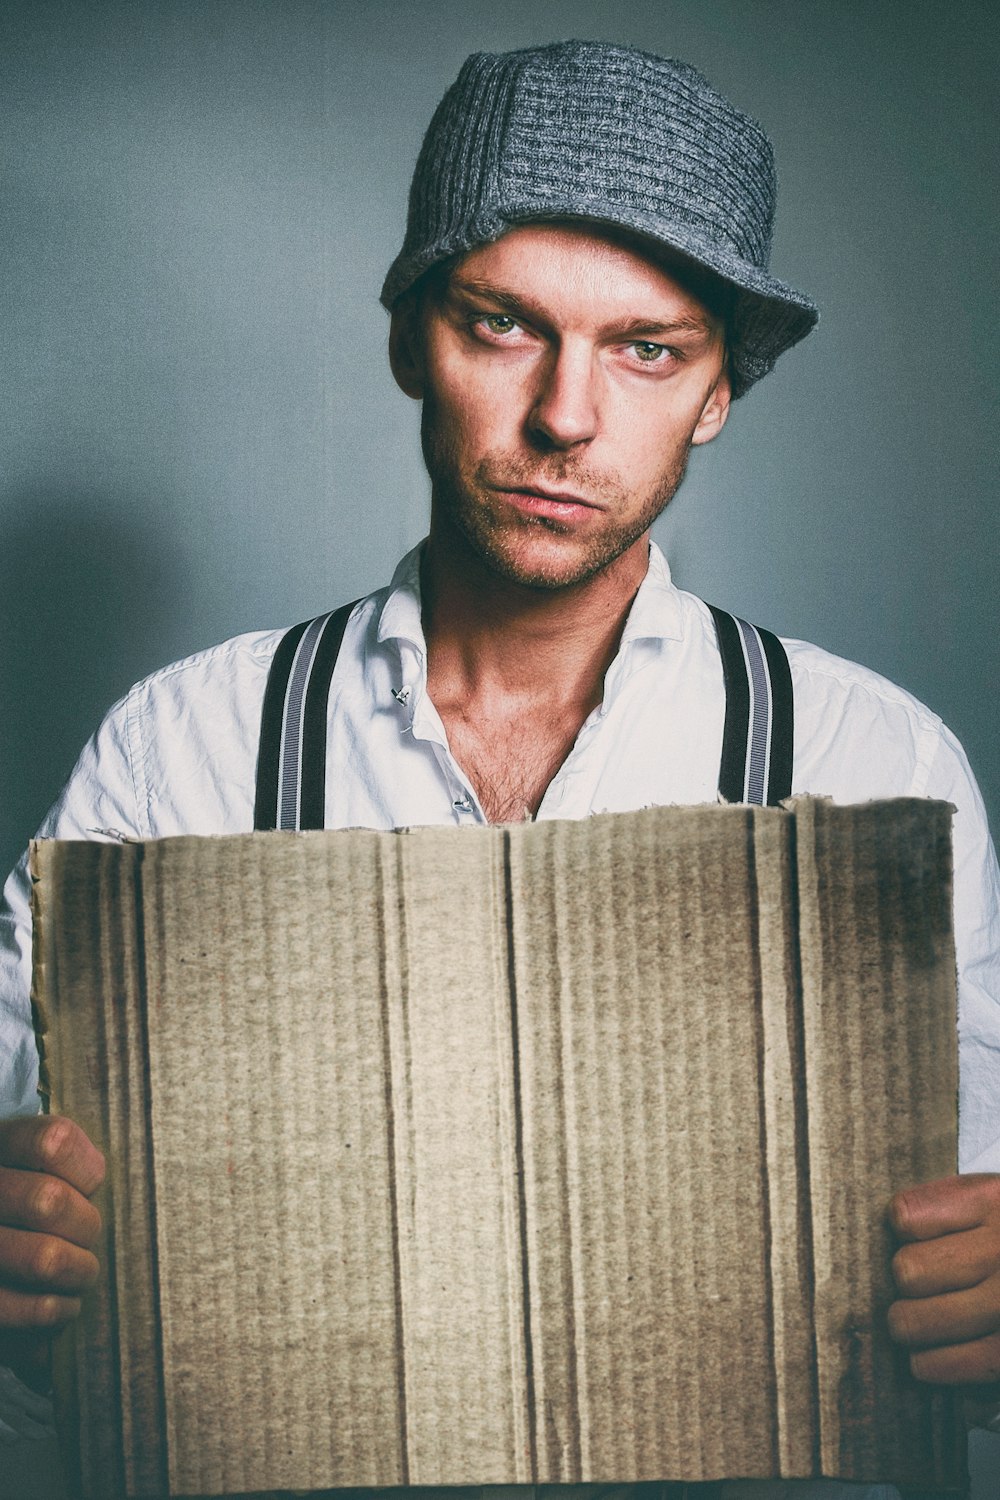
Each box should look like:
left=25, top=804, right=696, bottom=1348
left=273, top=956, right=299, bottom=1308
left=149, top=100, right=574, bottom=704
left=0, top=42, right=1000, bottom=1494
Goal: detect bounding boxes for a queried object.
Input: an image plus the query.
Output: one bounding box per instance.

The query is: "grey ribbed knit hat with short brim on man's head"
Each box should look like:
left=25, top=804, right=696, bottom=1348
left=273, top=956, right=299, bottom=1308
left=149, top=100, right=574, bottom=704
left=382, top=42, right=819, bottom=396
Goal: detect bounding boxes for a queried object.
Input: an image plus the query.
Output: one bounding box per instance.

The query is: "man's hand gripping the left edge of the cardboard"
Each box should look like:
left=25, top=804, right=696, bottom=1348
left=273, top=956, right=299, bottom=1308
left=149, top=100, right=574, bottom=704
left=0, top=1115, right=105, bottom=1367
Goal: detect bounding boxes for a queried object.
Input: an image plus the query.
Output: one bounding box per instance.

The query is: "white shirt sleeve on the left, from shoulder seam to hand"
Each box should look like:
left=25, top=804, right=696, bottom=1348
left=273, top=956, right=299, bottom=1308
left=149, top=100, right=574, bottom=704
left=0, top=699, right=145, bottom=1119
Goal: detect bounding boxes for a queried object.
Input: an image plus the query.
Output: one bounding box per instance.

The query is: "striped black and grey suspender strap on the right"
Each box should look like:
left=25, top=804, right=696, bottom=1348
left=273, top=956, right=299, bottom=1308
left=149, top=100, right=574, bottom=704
left=708, top=605, right=793, bottom=807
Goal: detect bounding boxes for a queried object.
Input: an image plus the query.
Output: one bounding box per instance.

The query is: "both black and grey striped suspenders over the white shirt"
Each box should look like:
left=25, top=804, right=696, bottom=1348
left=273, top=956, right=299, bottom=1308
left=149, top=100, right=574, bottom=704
left=253, top=605, right=793, bottom=830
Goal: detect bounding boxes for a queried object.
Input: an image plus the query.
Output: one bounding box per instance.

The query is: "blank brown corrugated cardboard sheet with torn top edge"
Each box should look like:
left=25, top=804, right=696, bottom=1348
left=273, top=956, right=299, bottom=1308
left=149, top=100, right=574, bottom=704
left=33, top=800, right=963, bottom=1500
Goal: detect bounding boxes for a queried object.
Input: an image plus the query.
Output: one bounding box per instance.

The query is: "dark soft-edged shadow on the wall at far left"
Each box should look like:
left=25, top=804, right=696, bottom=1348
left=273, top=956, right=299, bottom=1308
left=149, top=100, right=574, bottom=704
left=0, top=485, right=187, bottom=884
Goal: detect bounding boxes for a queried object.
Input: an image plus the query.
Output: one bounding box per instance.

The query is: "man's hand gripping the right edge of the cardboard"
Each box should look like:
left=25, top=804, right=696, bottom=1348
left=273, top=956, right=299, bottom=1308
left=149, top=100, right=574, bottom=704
left=889, top=1173, right=1000, bottom=1386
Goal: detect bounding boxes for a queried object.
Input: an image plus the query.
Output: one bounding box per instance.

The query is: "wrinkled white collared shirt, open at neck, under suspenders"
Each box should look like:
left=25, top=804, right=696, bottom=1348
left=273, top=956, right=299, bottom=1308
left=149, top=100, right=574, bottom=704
left=0, top=546, right=1000, bottom=1500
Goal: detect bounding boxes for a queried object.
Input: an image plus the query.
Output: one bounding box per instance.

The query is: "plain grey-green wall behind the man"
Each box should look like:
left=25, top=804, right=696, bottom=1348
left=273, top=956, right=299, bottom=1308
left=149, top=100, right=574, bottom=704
left=0, top=0, right=1000, bottom=1496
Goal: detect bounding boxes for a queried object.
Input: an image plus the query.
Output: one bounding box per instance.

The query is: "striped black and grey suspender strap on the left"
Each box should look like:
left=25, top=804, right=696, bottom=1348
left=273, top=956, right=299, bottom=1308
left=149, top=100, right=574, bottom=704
left=253, top=605, right=354, bottom=831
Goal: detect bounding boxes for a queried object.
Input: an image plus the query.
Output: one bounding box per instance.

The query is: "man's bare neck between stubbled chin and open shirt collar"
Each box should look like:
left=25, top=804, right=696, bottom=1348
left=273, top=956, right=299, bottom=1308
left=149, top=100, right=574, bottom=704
left=421, top=516, right=649, bottom=711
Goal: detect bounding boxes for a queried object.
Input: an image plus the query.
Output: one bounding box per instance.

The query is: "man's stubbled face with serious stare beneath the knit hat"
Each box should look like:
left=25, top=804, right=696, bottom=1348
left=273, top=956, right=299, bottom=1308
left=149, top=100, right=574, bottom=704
left=393, top=224, right=729, bottom=590
